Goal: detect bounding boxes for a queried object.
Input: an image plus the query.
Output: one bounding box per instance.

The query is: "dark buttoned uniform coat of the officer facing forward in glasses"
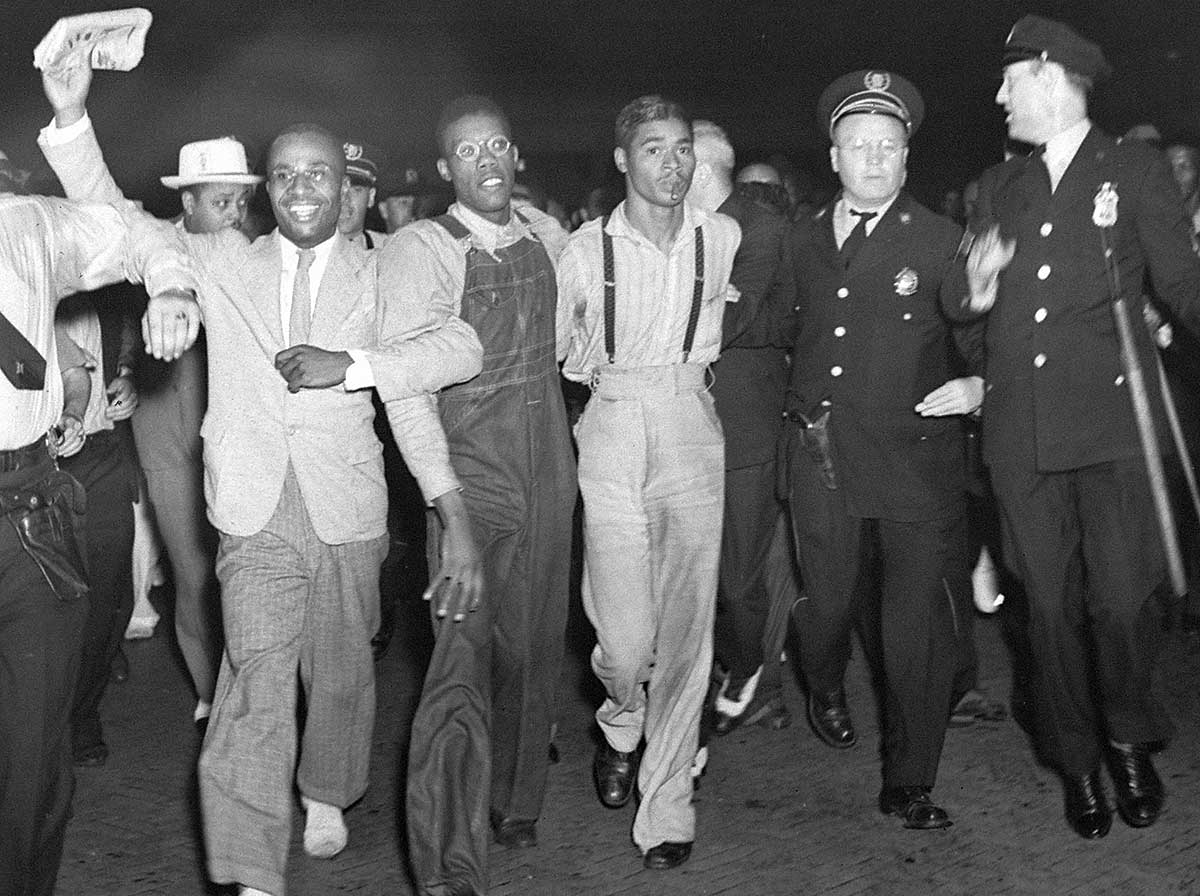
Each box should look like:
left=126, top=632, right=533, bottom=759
left=787, top=192, right=965, bottom=522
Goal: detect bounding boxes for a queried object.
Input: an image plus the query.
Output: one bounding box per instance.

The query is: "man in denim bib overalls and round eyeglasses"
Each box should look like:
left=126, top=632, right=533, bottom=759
left=379, top=96, right=576, bottom=896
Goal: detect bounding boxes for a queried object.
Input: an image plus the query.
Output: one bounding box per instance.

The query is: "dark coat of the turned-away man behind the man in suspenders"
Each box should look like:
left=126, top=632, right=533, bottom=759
left=712, top=193, right=796, bottom=470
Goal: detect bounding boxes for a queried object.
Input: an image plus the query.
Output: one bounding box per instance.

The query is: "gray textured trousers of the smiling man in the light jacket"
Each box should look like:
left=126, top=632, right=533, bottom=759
left=199, top=469, right=388, bottom=896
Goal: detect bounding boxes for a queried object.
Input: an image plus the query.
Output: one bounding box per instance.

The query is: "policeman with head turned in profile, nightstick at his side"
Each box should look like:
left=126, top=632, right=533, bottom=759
left=964, top=16, right=1200, bottom=838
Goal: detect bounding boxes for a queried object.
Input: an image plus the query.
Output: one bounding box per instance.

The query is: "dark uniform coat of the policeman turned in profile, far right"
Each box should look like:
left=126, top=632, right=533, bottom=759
left=960, top=127, right=1200, bottom=471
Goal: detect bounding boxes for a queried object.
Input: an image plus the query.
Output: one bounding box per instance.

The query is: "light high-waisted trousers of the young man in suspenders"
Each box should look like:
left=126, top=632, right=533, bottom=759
left=576, top=365, right=725, bottom=853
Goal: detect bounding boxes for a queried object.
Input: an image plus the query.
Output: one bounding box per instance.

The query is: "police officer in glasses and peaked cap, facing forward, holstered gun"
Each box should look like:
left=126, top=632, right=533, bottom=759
left=785, top=71, right=982, bottom=829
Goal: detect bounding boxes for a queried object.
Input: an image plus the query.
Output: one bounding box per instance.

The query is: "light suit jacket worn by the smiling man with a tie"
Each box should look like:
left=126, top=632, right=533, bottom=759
left=40, top=119, right=482, bottom=545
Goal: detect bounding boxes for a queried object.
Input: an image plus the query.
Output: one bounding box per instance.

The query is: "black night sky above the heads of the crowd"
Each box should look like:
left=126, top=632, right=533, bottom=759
left=0, top=0, right=1200, bottom=214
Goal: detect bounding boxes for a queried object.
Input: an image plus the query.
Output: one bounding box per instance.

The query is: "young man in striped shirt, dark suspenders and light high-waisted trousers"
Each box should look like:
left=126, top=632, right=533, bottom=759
left=558, top=96, right=740, bottom=870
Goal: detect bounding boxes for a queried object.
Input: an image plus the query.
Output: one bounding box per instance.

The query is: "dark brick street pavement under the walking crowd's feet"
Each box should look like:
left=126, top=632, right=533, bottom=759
left=51, top=587, right=1200, bottom=896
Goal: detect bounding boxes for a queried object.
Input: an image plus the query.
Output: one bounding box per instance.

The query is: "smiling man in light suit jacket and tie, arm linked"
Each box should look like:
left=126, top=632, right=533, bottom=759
left=41, top=59, right=481, bottom=896
